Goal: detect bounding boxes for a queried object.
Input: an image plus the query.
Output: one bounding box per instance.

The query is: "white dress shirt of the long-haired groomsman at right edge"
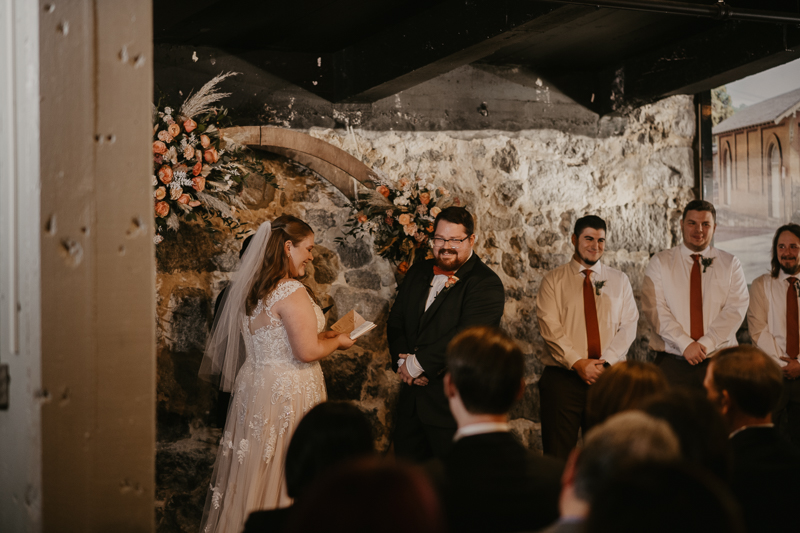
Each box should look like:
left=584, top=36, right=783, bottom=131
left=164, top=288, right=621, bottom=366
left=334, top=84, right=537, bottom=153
left=747, top=270, right=800, bottom=366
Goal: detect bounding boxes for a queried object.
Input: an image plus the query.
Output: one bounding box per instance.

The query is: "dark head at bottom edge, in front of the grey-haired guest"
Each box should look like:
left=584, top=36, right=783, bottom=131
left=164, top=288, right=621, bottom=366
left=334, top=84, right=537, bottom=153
left=585, top=463, right=744, bottom=533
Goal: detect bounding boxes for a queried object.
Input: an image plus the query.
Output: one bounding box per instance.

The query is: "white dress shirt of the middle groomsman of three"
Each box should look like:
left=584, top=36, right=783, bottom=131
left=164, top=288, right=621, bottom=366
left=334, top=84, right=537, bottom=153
left=642, top=244, right=750, bottom=356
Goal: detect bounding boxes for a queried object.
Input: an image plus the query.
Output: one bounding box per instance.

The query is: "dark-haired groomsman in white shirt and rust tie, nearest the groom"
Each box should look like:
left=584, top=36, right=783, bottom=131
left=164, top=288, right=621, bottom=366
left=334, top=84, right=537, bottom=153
left=536, top=215, right=639, bottom=459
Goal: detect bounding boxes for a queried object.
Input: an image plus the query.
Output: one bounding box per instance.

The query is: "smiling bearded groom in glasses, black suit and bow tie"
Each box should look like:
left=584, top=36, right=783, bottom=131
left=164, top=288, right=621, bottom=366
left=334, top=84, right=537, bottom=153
left=386, top=206, right=505, bottom=462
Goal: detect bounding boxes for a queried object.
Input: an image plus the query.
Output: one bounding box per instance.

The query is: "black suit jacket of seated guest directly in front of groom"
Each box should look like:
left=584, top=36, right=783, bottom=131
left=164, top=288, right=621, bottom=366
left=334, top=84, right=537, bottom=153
left=442, top=432, right=564, bottom=533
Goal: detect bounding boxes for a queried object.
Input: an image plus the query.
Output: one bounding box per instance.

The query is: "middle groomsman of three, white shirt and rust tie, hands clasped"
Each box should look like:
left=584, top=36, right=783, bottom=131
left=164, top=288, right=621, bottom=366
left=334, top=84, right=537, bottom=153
left=642, top=200, right=749, bottom=391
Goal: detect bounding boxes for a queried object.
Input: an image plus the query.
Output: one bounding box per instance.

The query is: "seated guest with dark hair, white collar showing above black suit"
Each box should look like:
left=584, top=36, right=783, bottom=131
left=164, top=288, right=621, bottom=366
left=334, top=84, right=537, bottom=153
left=442, top=326, right=564, bottom=532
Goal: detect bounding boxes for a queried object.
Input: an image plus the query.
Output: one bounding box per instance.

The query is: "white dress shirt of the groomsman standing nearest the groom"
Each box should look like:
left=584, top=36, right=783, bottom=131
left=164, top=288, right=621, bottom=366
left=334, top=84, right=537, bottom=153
left=536, top=259, right=639, bottom=369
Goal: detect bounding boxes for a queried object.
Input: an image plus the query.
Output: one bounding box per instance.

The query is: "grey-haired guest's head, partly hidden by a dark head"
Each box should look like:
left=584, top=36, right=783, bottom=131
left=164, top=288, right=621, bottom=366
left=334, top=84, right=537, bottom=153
left=545, top=411, right=680, bottom=533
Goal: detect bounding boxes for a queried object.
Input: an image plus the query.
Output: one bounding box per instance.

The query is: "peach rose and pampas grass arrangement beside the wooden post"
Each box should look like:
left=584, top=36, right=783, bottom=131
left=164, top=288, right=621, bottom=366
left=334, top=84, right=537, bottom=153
left=153, top=72, right=274, bottom=244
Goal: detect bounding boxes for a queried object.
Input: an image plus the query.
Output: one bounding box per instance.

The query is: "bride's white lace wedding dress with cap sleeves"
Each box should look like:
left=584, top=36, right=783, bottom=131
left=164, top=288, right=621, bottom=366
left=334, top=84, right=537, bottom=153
left=200, top=280, right=327, bottom=533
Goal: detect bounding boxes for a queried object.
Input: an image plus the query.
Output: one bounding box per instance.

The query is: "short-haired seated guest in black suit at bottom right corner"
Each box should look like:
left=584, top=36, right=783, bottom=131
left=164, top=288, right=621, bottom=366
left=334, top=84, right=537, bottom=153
left=704, top=346, right=800, bottom=532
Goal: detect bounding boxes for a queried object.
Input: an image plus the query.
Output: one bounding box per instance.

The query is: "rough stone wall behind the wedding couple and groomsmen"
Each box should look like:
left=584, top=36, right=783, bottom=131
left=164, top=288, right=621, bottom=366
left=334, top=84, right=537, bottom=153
left=157, top=92, right=695, bottom=531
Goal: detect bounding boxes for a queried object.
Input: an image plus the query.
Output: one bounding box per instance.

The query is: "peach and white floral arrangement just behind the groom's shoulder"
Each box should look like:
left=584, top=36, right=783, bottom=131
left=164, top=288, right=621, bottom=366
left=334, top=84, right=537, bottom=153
left=340, top=178, right=459, bottom=274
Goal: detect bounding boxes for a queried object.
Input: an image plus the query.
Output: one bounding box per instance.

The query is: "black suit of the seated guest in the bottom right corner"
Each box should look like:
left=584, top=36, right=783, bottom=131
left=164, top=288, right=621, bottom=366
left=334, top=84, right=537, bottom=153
left=731, top=427, right=800, bottom=533
